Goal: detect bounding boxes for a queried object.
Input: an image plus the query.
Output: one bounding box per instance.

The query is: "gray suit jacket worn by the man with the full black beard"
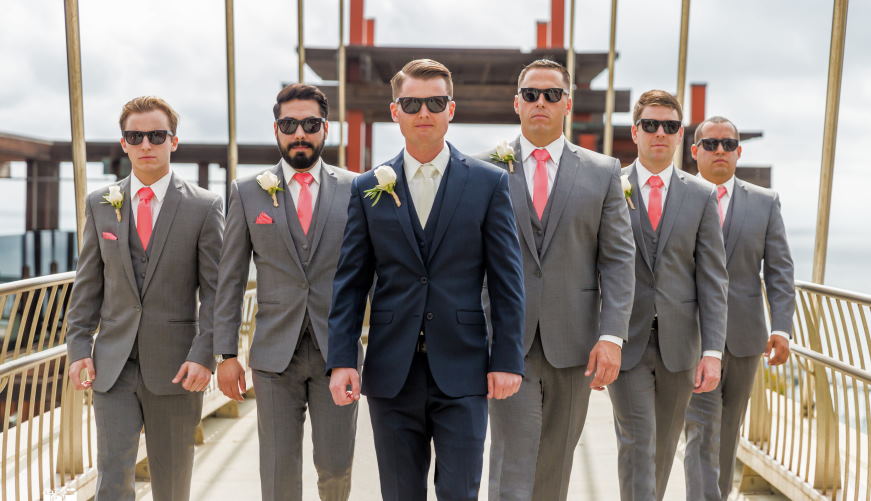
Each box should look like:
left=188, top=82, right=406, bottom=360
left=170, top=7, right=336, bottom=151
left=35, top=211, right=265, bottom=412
left=213, top=162, right=363, bottom=372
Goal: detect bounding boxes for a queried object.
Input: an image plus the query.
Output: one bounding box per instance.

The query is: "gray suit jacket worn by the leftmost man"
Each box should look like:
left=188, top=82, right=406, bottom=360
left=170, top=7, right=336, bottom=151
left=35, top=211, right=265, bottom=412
left=67, top=174, right=224, bottom=395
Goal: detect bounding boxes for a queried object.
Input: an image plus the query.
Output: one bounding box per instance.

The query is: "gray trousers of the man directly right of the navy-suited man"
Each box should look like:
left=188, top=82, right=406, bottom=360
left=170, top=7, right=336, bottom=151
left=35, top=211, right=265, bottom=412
left=489, top=333, right=592, bottom=501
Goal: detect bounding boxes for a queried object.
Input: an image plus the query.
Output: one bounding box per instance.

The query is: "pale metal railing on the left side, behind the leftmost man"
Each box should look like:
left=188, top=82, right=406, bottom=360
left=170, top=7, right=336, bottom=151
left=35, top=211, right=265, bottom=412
left=0, top=272, right=257, bottom=501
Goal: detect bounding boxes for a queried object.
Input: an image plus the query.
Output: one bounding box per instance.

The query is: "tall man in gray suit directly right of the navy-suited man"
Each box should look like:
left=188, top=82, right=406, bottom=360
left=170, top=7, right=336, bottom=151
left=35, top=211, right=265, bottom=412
left=486, top=59, right=635, bottom=501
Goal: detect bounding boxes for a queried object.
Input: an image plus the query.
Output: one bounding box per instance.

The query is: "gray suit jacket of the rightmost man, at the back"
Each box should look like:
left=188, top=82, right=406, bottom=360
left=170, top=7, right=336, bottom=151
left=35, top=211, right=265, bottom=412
left=724, top=178, right=795, bottom=357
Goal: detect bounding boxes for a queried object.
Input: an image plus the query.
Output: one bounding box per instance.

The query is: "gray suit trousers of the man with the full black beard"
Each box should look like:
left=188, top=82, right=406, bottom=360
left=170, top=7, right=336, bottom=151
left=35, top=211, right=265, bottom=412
left=253, top=329, right=357, bottom=501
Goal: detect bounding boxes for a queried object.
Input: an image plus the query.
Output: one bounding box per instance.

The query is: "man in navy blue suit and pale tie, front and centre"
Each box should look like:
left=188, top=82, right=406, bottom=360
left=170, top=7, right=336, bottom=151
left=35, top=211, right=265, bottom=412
left=327, top=59, right=524, bottom=501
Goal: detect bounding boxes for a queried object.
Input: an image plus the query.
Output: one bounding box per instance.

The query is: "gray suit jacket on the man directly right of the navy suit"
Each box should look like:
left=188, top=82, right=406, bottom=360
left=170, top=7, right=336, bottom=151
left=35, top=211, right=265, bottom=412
left=481, top=138, right=635, bottom=368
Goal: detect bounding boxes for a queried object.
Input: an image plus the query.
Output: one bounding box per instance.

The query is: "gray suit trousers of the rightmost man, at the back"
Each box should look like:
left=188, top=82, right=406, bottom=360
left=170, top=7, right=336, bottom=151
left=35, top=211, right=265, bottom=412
left=684, top=351, right=759, bottom=501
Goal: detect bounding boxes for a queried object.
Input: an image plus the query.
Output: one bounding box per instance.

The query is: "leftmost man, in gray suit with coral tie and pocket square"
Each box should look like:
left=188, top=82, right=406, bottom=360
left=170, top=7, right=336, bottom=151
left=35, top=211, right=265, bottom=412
left=67, top=97, right=224, bottom=501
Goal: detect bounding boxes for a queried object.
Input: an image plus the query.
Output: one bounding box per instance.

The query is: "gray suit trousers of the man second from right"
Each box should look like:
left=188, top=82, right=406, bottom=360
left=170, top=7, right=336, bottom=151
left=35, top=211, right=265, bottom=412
left=608, top=331, right=695, bottom=501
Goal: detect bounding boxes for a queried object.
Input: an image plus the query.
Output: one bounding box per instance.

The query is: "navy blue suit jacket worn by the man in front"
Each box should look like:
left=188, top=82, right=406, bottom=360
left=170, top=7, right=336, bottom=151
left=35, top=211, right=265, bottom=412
left=327, top=145, right=524, bottom=398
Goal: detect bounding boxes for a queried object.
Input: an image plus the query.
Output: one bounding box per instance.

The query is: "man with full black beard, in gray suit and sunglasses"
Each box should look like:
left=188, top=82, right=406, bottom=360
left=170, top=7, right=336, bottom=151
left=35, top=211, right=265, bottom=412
left=214, top=83, right=362, bottom=501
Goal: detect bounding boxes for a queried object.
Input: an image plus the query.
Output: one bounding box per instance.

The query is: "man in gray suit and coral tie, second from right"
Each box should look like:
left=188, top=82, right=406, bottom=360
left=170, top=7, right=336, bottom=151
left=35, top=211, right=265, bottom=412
left=609, top=90, right=728, bottom=501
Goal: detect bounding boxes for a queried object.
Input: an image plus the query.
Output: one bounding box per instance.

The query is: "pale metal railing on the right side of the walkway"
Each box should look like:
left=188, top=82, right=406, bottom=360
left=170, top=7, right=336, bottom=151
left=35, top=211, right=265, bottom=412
left=738, top=282, right=871, bottom=500
